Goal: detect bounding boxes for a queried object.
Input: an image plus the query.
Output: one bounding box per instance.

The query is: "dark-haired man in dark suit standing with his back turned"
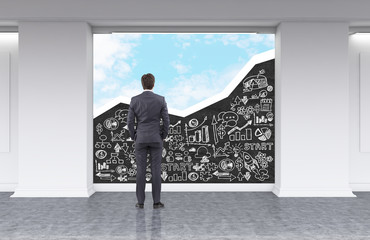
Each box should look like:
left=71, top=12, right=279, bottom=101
left=127, top=73, right=169, bottom=208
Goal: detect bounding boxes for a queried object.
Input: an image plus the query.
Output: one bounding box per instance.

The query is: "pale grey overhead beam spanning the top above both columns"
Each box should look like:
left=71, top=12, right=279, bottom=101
left=0, top=0, right=370, bottom=26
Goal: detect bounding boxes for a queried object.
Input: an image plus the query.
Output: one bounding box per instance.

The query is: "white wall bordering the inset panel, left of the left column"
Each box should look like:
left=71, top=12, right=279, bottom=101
left=0, top=33, right=18, bottom=191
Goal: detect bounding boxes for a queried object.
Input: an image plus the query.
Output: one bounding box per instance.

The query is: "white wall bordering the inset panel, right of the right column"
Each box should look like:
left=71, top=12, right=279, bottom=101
left=349, top=34, right=370, bottom=191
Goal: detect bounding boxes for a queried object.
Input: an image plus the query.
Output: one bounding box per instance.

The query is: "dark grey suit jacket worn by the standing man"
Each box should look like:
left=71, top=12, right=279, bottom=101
left=127, top=91, right=170, bottom=143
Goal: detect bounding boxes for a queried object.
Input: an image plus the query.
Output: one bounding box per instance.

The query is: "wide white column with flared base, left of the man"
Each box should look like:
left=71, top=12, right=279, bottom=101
left=13, top=22, right=94, bottom=197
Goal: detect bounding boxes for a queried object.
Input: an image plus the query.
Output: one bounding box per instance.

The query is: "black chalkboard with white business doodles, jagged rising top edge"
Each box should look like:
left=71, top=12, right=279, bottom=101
left=94, top=60, right=275, bottom=183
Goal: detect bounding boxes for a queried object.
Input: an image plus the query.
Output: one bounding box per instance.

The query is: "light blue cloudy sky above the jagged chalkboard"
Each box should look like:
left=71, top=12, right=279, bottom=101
left=94, top=34, right=275, bottom=110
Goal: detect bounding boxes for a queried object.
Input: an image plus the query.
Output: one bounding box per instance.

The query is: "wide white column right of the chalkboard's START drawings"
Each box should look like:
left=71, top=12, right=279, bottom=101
left=273, top=22, right=354, bottom=197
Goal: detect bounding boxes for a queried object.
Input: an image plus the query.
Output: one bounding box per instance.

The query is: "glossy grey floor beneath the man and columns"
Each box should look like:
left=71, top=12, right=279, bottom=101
left=0, top=193, right=370, bottom=240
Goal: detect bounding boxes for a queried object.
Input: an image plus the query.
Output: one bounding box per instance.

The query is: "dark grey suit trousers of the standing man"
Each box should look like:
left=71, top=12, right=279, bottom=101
left=135, top=142, right=163, bottom=204
